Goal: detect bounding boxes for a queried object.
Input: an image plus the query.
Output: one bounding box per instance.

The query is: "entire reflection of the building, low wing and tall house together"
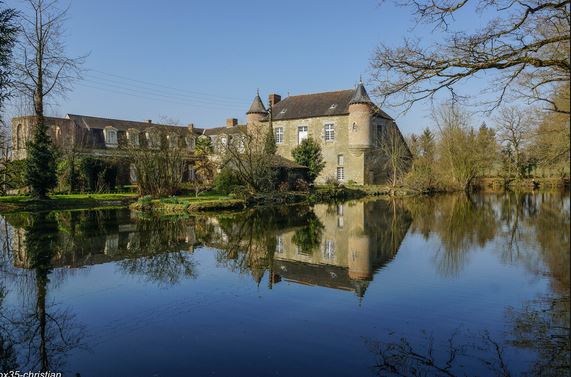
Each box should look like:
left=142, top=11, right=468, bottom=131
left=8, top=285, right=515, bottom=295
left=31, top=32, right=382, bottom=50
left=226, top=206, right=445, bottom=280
left=6, top=201, right=410, bottom=296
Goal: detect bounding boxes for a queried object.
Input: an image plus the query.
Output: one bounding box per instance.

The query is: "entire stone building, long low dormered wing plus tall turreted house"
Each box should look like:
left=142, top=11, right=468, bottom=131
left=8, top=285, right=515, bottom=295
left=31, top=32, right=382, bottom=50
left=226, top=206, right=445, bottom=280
left=12, top=83, right=410, bottom=184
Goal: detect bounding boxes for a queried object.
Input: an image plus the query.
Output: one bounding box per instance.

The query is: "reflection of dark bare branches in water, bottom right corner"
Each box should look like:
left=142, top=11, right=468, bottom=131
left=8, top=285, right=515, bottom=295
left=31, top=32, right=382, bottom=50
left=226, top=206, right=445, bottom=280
left=367, top=299, right=570, bottom=376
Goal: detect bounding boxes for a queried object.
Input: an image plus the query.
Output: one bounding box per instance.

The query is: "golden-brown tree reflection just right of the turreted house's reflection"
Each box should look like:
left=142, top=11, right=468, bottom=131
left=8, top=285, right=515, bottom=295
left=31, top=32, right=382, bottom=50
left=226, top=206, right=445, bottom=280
left=406, top=195, right=498, bottom=276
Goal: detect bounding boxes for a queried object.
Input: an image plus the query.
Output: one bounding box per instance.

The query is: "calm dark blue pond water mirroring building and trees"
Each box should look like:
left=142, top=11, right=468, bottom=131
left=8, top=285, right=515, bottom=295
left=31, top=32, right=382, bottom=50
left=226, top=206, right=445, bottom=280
left=0, top=193, right=570, bottom=377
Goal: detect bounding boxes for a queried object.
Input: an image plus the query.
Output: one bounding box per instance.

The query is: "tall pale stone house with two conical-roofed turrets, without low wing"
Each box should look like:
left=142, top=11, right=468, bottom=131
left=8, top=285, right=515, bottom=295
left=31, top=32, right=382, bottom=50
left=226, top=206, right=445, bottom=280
left=247, top=83, right=410, bottom=184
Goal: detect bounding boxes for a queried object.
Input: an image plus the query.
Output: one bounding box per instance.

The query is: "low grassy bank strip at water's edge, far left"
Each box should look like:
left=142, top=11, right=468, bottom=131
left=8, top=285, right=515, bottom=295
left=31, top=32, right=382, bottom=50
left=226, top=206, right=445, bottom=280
left=0, top=193, right=137, bottom=213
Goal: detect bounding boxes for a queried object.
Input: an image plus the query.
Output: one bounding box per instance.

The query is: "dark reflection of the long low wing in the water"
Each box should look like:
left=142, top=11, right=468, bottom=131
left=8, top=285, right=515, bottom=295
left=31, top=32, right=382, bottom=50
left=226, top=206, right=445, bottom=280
left=7, top=210, right=196, bottom=268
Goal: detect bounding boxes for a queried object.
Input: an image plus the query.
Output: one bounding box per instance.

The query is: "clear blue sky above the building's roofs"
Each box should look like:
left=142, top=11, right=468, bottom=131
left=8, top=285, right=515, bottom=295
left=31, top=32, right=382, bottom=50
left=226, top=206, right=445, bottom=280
left=6, top=0, right=496, bottom=134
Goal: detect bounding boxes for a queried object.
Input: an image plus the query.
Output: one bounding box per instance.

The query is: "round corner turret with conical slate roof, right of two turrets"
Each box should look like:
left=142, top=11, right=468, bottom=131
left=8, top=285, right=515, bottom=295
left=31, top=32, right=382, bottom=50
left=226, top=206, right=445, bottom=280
left=349, top=81, right=374, bottom=153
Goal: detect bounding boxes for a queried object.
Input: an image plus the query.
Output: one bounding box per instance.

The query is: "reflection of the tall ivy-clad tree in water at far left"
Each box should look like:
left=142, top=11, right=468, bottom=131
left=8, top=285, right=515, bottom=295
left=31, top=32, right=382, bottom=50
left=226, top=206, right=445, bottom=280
left=3, top=213, right=83, bottom=371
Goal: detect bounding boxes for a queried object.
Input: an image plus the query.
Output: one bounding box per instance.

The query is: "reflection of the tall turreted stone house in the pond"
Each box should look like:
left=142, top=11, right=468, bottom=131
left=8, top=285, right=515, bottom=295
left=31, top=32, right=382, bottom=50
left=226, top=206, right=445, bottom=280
left=273, top=201, right=411, bottom=296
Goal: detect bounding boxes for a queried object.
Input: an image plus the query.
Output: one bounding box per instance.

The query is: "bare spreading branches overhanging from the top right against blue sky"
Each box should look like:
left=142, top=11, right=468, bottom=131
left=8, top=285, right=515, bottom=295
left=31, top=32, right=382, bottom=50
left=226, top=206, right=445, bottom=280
left=371, top=0, right=571, bottom=114
